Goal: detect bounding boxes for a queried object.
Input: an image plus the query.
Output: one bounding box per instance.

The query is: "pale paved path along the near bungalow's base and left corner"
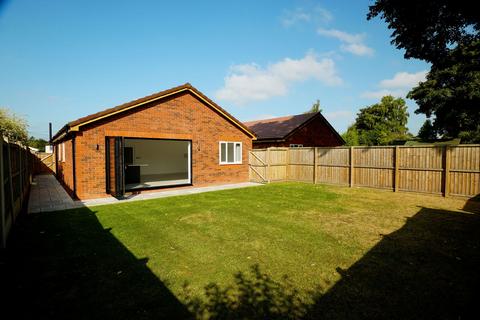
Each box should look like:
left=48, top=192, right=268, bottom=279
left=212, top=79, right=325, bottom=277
left=28, top=175, right=262, bottom=213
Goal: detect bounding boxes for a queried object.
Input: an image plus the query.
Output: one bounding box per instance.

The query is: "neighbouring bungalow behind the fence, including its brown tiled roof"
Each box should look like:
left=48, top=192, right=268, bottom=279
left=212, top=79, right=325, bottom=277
left=244, top=112, right=345, bottom=149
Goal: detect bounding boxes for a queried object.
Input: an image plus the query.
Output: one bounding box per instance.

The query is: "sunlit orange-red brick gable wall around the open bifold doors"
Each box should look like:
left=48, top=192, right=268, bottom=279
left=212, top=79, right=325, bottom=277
left=66, top=92, right=252, bottom=199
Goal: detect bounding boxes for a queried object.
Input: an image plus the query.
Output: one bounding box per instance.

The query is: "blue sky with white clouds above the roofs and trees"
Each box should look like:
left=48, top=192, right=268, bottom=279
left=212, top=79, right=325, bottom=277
left=0, top=0, right=429, bottom=138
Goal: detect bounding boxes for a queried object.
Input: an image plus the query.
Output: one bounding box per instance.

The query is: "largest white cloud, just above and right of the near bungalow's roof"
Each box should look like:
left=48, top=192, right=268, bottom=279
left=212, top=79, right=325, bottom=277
left=215, top=52, right=342, bottom=105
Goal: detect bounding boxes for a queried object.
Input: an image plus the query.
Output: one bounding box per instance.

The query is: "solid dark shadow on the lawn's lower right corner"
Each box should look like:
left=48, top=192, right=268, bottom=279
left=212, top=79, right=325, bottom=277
left=307, top=208, right=480, bottom=319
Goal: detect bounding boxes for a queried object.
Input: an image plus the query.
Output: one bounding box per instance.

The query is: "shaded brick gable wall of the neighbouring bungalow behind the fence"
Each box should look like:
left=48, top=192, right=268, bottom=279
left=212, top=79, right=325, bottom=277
left=253, top=117, right=343, bottom=148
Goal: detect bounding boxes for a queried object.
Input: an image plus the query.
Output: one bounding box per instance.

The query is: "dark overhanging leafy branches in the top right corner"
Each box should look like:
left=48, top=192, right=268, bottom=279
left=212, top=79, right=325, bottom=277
left=367, top=0, right=480, bottom=63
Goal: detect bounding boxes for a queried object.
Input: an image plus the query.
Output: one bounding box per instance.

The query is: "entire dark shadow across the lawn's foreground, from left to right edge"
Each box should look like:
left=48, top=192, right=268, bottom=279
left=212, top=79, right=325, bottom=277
left=2, top=204, right=480, bottom=319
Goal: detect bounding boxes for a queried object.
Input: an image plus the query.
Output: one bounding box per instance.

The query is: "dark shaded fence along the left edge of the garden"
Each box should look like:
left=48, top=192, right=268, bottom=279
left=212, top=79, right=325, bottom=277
left=0, top=136, right=38, bottom=248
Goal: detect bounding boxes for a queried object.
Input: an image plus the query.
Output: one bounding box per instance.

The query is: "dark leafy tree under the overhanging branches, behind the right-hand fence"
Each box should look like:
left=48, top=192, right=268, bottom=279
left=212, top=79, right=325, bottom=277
left=407, top=41, right=480, bottom=143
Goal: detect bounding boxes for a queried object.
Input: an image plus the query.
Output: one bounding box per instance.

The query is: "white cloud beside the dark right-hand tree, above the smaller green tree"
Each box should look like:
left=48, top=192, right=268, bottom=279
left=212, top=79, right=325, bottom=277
left=360, top=70, right=427, bottom=99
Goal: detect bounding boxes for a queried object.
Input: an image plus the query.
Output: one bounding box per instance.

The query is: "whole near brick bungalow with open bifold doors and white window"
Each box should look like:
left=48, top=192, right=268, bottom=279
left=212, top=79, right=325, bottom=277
left=52, top=83, right=255, bottom=199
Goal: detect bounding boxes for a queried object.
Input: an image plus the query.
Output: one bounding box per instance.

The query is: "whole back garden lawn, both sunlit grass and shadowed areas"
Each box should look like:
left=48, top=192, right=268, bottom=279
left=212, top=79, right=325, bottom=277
left=0, top=183, right=480, bottom=319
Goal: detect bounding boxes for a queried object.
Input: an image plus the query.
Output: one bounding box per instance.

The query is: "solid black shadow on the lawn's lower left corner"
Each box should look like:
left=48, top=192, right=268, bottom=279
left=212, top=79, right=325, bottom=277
left=0, top=208, right=191, bottom=319
